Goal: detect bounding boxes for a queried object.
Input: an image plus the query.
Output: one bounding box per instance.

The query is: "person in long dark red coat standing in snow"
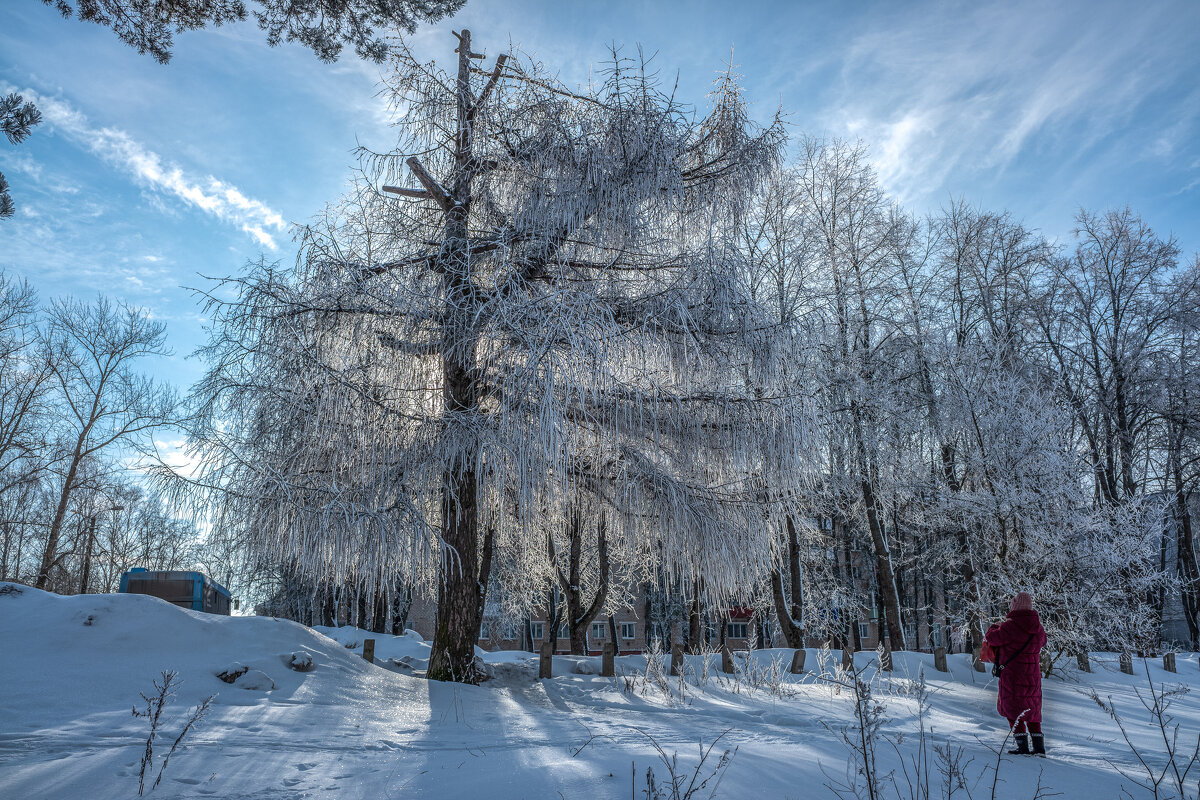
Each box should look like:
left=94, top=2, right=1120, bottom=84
left=985, top=591, right=1046, bottom=756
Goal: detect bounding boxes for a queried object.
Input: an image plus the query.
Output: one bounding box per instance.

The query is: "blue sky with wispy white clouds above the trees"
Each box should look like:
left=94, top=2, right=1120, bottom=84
left=0, top=0, right=1200, bottom=398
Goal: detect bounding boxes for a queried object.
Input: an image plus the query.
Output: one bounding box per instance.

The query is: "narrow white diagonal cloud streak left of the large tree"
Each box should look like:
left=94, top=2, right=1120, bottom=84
left=7, top=84, right=287, bottom=249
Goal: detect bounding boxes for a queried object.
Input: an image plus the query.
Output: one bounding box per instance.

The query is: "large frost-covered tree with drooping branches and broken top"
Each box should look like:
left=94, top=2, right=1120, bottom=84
left=184, top=31, right=806, bottom=680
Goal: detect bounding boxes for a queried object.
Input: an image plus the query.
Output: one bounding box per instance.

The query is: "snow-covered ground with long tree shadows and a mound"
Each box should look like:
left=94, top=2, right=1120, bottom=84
left=0, top=583, right=1200, bottom=800
